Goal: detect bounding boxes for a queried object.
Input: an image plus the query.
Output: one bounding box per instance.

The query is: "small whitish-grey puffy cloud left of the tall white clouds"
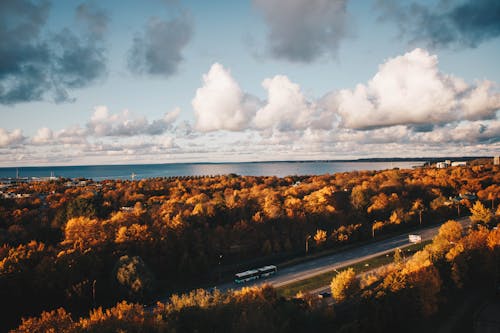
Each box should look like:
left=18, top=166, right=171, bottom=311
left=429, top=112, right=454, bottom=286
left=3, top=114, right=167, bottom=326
left=87, top=105, right=180, bottom=137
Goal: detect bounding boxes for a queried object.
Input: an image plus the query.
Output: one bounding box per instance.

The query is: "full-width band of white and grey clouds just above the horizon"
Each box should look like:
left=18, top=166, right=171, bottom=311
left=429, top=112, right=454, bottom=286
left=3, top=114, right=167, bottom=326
left=0, top=48, right=500, bottom=163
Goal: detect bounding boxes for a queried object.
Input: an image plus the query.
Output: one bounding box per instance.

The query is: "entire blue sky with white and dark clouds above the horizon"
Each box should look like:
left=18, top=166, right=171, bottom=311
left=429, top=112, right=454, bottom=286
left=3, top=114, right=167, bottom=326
left=0, top=0, right=500, bottom=166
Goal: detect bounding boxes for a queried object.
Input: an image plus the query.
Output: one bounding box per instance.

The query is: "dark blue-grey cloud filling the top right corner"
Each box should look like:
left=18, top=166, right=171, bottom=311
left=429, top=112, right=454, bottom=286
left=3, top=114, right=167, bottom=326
left=378, top=0, right=500, bottom=48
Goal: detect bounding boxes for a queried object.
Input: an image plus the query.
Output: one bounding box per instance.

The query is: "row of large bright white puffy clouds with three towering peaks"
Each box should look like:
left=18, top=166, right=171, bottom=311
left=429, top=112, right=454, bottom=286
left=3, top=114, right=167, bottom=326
left=192, top=48, right=500, bottom=132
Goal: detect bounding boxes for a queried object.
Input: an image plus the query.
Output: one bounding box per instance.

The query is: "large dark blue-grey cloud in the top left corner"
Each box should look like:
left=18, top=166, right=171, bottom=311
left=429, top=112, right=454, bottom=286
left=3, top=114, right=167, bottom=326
left=0, top=0, right=106, bottom=104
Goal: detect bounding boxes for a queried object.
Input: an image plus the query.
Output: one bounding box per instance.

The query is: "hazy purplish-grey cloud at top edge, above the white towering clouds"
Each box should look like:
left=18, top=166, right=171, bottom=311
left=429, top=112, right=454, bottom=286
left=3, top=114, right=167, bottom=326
left=253, top=0, right=348, bottom=62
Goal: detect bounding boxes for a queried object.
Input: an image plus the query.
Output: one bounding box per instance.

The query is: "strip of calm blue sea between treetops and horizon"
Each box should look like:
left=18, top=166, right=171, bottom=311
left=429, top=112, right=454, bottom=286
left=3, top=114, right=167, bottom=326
left=0, top=161, right=423, bottom=180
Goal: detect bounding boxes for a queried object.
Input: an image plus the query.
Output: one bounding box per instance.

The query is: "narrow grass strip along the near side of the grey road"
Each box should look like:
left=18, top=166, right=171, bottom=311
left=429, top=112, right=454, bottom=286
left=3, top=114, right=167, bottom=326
left=277, top=241, right=431, bottom=297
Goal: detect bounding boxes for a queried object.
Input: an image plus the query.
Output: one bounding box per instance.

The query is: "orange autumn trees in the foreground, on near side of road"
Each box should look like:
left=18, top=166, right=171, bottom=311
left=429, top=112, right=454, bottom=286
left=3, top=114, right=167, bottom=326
left=13, top=221, right=500, bottom=333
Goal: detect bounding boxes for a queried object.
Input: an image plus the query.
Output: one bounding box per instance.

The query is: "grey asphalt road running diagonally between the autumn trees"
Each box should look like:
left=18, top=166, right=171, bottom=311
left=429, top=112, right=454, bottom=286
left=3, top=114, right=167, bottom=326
left=215, top=217, right=470, bottom=291
